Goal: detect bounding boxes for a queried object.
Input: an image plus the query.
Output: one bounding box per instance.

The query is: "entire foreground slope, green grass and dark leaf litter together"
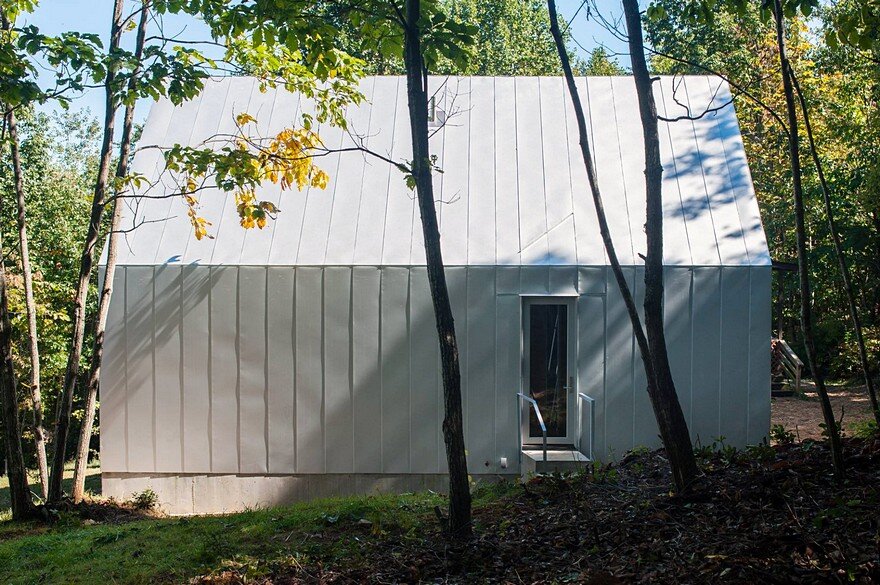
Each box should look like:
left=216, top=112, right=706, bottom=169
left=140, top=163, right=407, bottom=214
left=0, top=439, right=880, bottom=584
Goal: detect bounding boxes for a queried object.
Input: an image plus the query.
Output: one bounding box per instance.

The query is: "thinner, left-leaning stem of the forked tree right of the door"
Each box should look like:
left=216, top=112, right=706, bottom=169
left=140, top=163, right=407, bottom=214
left=547, top=0, right=696, bottom=491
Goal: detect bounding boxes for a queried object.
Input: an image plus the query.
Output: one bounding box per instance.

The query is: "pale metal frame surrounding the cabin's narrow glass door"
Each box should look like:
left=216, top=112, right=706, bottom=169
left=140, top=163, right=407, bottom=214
left=519, top=295, right=578, bottom=446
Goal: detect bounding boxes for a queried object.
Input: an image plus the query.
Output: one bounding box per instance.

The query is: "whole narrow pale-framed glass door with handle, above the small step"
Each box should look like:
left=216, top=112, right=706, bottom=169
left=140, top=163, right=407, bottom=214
left=522, top=297, right=577, bottom=445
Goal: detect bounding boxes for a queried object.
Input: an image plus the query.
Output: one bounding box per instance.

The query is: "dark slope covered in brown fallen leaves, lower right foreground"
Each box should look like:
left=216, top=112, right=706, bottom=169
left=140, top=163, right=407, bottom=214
left=194, top=439, right=880, bottom=584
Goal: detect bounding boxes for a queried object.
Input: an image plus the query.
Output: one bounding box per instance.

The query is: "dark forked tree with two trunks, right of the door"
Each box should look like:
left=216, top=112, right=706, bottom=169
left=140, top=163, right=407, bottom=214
left=547, top=0, right=697, bottom=492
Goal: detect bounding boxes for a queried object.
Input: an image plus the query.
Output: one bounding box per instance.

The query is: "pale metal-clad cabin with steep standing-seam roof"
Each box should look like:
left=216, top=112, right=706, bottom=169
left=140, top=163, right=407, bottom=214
left=100, top=77, right=771, bottom=514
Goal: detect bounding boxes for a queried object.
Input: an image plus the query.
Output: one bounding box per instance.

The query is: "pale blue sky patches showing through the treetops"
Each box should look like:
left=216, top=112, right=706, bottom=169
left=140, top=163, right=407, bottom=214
left=20, top=0, right=629, bottom=121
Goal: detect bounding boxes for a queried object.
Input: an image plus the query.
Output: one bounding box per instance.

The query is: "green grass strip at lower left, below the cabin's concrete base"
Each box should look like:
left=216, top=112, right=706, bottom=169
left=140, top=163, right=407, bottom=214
left=0, top=486, right=511, bottom=584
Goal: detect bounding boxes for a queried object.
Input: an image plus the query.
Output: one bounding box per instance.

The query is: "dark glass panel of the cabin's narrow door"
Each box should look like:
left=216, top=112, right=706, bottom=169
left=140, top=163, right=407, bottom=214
left=529, top=304, right=568, bottom=437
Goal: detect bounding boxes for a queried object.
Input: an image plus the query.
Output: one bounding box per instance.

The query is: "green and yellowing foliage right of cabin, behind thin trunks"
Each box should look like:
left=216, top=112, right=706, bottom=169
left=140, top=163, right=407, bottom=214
left=645, top=0, right=880, bottom=377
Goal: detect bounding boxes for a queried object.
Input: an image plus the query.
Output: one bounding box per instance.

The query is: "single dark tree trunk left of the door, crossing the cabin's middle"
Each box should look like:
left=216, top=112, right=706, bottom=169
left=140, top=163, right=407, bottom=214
left=402, top=0, right=472, bottom=538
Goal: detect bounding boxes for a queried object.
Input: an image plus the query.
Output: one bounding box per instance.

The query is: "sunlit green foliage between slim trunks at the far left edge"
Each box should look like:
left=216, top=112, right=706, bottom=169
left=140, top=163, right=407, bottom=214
left=0, top=109, right=99, bottom=453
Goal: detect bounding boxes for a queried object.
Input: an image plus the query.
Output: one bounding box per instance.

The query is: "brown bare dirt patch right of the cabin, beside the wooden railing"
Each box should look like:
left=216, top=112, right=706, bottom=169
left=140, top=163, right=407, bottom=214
left=770, top=383, right=871, bottom=441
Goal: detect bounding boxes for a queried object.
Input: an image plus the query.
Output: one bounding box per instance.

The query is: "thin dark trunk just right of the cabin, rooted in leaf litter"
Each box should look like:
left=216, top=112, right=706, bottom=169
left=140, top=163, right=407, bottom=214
left=773, top=0, right=844, bottom=479
